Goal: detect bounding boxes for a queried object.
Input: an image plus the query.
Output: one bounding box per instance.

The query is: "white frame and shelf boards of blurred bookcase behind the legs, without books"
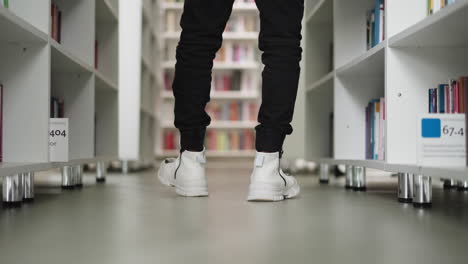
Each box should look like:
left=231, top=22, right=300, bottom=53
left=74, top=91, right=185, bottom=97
left=155, top=0, right=261, bottom=158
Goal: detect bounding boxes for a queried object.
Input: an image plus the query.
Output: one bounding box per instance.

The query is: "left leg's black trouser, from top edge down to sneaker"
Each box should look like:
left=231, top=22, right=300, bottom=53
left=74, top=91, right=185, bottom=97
left=173, top=0, right=234, bottom=151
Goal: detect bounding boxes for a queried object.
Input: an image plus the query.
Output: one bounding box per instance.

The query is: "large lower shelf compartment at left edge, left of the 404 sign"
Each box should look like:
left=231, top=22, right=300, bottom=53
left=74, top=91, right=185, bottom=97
left=0, top=43, right=50, bottom=163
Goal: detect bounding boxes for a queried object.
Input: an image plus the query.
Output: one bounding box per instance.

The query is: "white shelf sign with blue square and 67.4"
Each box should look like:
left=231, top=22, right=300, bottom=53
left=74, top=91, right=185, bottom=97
left=417, top=114, right=466, bottom=167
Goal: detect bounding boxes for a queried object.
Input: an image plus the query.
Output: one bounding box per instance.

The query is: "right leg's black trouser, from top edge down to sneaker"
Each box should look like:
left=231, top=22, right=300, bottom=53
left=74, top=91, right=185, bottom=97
left=256, top=0, right=304, bottom=152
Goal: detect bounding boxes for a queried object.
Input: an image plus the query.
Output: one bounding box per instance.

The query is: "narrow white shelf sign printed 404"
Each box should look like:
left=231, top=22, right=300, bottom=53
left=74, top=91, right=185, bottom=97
left=49, top=118, right=69, bottom=162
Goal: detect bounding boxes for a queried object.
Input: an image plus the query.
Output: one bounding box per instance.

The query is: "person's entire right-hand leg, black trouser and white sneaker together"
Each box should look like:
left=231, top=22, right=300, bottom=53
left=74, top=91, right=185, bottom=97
left=247, top=0, right=304, bottom=201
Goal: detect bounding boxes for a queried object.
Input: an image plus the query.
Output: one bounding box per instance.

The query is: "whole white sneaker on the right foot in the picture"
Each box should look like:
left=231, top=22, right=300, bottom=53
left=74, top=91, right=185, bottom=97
left=247, top=152, right=300, bottom=201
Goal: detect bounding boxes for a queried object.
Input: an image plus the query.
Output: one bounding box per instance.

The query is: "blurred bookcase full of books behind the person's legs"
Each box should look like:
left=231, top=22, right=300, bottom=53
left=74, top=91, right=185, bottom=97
left=155, top=0, right=261, bottom=158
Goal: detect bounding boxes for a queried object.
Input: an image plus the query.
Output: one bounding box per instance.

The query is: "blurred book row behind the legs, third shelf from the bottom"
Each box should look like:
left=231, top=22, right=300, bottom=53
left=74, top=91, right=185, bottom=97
left=164, top=70, right=258, bottom=92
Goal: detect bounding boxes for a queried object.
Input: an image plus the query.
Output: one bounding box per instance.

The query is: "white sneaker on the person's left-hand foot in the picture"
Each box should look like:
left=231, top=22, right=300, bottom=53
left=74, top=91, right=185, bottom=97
left=158, top=151, right=208, bottom=197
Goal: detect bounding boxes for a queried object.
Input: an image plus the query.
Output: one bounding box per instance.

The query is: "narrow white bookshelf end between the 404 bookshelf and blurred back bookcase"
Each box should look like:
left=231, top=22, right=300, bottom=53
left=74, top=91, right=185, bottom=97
left=118, top=0, right=161, bottom=171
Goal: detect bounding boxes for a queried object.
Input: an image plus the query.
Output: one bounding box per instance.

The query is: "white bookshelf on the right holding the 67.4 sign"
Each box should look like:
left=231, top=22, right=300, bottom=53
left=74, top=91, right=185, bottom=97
left=304, top=0, right=468, bottom=204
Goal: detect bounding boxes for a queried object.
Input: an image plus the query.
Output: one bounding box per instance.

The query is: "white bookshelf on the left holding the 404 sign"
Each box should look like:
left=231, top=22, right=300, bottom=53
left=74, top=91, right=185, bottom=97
left=0, top=0, right=119, bottom=203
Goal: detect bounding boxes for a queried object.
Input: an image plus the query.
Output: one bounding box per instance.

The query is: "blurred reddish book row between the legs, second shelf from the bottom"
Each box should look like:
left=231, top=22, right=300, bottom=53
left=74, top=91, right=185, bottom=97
left=206, top=102, right=258, bottom=121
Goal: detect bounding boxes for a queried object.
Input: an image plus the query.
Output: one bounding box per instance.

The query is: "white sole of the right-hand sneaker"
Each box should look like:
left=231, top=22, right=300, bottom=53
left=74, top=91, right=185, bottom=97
left=247, top=183, right=300, bottom=202
